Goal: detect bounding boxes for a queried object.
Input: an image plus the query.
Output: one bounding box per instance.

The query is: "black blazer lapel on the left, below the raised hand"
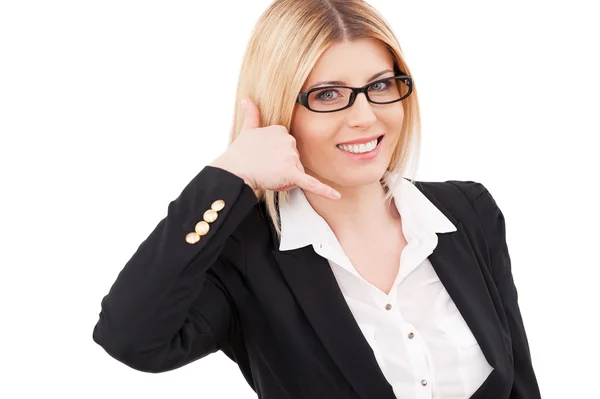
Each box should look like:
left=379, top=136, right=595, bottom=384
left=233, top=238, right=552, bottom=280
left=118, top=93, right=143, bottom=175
left=273, top=245, right=395, bottom=399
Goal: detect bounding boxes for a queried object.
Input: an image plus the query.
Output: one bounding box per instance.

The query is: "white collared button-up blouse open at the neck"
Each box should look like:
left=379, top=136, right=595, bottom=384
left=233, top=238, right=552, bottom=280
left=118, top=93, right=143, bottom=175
left=279, top=173, right=492, bottom=399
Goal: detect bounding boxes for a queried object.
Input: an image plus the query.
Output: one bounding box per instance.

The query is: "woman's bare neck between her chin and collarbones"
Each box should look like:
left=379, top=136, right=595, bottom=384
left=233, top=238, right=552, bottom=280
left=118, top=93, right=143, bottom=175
left=304, top=175, right=400, bottom=237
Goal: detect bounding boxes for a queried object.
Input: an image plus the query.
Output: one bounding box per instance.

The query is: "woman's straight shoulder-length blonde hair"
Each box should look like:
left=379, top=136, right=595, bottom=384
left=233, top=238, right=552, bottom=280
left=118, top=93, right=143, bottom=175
left=229, top=0, right=421, bottom=238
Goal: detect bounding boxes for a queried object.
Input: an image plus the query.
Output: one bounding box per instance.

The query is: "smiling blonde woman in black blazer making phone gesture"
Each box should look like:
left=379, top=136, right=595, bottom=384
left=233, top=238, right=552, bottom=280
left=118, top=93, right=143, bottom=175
left=93, top=0, right=540, bottom=399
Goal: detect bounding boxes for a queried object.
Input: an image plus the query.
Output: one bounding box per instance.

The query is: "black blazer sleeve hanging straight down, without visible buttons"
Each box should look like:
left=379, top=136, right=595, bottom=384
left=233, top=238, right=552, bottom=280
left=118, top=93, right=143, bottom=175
left=471, top=183, right=541, bottom=399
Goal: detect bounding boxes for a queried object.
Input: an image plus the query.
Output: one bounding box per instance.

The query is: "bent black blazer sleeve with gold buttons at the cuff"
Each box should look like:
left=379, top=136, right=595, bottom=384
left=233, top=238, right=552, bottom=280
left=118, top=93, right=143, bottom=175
left=93, top=166, right=257, bottom=372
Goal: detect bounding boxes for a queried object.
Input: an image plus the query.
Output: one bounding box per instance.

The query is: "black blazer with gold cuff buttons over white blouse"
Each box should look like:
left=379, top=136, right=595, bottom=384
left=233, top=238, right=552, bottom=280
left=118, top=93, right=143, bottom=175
left=93, top=166, right=540, bottom=399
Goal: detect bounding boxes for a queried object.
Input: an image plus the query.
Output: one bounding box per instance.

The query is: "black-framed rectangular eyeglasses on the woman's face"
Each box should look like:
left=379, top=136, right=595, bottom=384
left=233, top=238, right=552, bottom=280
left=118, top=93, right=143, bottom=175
left=297, top=75, right=413, bottom=112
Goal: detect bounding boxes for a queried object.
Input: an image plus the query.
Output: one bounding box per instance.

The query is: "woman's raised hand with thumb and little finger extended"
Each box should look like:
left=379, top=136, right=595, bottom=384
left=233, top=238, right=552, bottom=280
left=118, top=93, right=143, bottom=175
left=211, top=100, right=341, bottom=199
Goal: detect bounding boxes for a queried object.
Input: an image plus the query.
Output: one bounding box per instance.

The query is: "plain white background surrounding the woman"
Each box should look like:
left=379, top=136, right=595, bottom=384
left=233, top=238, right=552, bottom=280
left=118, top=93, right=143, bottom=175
left=0, top=0, right=600, bottom=399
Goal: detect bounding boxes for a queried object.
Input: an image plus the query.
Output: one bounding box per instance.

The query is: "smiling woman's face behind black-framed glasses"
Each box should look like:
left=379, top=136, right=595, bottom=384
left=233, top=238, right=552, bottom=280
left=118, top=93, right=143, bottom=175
left=290, top=39, right=404, bottom=188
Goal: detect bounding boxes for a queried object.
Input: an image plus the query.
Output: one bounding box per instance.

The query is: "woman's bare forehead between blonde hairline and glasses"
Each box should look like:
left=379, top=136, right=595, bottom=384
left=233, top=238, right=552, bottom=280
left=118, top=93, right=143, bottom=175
left=303, top=38, right=394, bottom=88
